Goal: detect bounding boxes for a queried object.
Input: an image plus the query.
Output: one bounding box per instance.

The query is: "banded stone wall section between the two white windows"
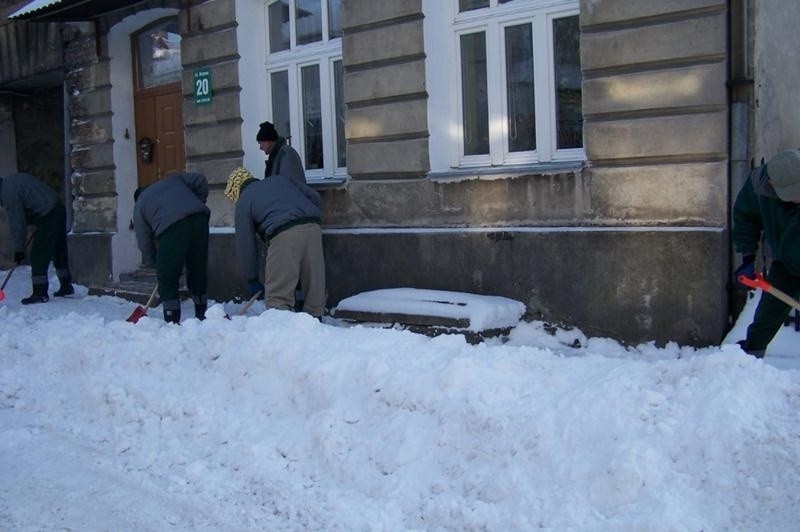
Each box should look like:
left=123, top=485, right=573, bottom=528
left=342, top=0, right=430, bottom=180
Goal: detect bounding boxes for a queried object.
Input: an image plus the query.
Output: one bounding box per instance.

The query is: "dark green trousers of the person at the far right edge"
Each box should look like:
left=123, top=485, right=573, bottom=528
left=747, top=261, right=800, bottom=351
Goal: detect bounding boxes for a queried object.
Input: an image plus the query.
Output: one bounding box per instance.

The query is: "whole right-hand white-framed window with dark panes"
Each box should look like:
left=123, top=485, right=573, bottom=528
left=424, top=0, right=585, bottom=169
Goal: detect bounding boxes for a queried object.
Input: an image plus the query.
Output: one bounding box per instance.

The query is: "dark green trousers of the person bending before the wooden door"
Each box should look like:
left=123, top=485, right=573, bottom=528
left=156, top=213, right=208, bottom=310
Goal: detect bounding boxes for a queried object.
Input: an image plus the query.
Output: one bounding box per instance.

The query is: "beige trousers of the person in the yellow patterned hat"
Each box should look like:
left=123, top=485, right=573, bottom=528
left=264, top=223, right=325, bottom=318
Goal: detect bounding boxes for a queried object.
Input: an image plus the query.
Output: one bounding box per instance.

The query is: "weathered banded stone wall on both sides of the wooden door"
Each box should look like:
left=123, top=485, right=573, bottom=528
left=64, top=0, right=241, bottom=283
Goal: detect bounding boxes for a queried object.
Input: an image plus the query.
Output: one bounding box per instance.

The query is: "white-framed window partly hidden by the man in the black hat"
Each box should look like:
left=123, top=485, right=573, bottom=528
left=265, top=0, right=347, bottom=181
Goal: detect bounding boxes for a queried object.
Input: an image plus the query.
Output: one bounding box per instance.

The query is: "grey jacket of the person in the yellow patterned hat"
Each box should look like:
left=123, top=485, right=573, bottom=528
left=235, top=175, right=322, bottom=281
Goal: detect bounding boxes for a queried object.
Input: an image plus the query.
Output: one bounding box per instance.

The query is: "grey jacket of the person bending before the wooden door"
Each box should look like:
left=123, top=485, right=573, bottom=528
left=133, top=172, right=210, bottom=266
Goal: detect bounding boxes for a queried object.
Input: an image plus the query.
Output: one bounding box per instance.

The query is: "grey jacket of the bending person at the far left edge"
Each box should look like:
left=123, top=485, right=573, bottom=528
left=0, top=173, right=59, bottom=252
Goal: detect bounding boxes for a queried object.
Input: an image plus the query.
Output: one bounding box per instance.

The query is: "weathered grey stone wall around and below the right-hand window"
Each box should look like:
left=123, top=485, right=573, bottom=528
left=324, top=0, right=728, bottom=344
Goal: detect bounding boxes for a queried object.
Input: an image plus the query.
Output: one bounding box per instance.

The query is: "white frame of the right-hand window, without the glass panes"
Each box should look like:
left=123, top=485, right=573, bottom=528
left=423, top=0, right=586, bottom=172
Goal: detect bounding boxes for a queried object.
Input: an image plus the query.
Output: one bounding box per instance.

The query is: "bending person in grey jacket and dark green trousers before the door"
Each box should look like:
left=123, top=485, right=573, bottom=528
left=133, top=173, right=210, bottom=323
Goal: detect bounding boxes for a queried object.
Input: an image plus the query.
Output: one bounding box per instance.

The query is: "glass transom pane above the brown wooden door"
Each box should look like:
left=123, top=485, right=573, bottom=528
left=136, top=18, right=182, bottom=89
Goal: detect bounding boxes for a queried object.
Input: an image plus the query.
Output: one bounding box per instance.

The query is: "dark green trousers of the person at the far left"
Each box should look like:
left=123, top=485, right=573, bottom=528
left=31, top=203, right=70, bottom=285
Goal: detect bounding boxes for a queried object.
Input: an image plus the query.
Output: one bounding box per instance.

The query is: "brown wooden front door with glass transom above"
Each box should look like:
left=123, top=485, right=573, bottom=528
left=132, top=17, right=186, bottom=186
